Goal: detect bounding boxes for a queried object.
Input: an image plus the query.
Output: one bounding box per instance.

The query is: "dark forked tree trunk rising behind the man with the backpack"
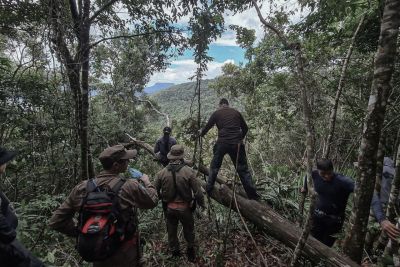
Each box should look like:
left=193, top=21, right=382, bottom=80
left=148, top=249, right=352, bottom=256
left=49, top=0, right=94, bottom=180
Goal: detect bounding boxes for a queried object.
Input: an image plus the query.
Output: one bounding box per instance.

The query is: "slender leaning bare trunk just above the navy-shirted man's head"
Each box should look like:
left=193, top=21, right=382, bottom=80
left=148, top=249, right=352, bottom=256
left=322, top=14, right=365, bottom=158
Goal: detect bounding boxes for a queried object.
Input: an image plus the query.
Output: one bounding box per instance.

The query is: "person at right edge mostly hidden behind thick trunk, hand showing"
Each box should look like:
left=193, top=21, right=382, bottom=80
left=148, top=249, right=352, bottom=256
left=371, top=157, right=400, bottom=240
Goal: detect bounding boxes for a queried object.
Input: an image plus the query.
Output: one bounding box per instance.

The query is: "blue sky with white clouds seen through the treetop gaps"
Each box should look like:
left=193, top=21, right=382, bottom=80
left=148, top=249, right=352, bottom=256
left=147, top=0, right=304, bottom=86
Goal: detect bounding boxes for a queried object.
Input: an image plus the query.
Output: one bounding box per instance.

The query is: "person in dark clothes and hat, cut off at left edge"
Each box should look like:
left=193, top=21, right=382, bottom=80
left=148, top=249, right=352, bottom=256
left=0, top=148, right=44, bottom=267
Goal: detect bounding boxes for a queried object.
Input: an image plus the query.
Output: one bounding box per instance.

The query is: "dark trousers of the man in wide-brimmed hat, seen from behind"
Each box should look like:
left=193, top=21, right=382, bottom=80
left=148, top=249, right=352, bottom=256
left=166, top=208, right=195, bottom=252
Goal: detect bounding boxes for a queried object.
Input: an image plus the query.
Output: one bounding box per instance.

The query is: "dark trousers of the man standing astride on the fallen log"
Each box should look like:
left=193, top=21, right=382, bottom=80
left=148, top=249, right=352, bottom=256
left=207, top=143, right=259, bottom=199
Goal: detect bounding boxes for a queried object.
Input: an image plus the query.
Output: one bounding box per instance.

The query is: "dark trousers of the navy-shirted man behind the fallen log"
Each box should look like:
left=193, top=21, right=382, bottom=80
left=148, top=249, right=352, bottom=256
left=311, top=215, right=343, bottom=247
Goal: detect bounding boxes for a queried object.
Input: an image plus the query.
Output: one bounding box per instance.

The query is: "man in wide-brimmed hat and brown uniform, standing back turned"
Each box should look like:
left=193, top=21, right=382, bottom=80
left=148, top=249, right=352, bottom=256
left=155, top=145, right=204, bottom=262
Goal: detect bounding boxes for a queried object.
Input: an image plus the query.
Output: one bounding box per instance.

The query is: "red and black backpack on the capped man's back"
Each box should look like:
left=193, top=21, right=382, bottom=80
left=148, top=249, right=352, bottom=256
left=76, top=178, right=126, bottom=262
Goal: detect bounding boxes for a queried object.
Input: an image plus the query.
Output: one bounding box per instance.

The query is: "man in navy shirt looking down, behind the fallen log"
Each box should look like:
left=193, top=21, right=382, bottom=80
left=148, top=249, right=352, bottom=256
left=301, top=159, right=354, bottom=247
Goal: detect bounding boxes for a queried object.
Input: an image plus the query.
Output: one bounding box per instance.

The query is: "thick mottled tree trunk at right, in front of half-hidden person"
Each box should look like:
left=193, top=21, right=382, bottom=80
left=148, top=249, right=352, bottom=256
left=343, top=0, right=400, bottom=262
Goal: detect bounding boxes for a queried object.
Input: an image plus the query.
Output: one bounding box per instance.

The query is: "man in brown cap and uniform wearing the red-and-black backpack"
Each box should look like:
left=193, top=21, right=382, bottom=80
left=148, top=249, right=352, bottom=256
left=50, top=145, right=158, bottom=267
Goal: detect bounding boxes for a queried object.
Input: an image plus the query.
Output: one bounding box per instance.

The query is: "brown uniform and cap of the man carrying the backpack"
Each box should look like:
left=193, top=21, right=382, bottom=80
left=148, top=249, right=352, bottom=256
left=50, top=145, right=158, bottom=267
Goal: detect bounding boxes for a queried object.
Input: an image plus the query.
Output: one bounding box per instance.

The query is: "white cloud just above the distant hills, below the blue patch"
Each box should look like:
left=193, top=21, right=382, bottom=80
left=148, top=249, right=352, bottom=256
left=148, top=59, right=234, bottom=86
